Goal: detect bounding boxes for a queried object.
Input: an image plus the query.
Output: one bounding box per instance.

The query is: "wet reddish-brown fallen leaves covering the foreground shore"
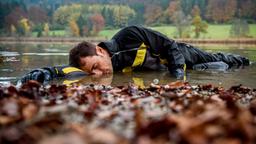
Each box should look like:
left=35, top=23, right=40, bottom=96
left=0, top=81, right=256, bottom=144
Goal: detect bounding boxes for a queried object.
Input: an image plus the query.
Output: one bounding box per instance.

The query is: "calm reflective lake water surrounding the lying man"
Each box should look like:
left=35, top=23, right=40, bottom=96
left=0, top=44, right=256, bottom=88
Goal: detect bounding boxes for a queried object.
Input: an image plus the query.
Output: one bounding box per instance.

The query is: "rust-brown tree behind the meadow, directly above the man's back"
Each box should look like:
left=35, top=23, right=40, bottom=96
left=144, top=4, right=163, bottom=25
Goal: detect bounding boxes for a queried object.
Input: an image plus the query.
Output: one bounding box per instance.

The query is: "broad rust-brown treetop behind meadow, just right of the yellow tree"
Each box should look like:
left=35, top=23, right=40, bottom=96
left=207, top=0, right=237, bottom=23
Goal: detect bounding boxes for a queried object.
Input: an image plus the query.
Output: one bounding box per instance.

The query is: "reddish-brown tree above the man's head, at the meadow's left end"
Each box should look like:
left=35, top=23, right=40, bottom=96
left=89, top=14, right=105, bottom=35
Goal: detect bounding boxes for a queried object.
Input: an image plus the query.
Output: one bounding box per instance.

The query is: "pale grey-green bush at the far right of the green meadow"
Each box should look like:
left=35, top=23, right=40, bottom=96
left=230, top=19, right=249, bottom=37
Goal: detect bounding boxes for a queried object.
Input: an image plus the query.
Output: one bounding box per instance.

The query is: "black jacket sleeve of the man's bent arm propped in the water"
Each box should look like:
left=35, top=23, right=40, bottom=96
left=129, top=26, right=185, bottom=78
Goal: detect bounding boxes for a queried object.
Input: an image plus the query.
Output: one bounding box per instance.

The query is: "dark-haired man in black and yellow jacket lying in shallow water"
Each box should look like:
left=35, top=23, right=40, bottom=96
left=21, top=26, right=250, bottom=83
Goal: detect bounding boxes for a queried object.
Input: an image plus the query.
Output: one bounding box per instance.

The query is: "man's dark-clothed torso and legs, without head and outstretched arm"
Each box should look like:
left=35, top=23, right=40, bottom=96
left=98, top=26, right=249, bottom=78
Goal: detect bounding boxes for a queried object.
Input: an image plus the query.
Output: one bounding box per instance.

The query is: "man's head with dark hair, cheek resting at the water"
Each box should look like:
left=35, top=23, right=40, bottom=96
left=69, top=42, right=113, bottom=75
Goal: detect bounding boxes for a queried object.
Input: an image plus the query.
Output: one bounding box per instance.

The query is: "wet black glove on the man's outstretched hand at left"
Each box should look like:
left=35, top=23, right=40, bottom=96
left=21, top=69, right=53, bottom=84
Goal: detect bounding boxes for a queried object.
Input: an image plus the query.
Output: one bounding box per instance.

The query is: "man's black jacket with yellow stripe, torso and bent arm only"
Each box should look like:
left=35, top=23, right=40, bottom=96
left=98, top=26, right=185, bottom=75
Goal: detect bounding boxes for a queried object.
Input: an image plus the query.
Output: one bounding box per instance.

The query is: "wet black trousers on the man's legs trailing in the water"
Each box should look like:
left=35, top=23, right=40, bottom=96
left=178, top=43, right=250, bottom=68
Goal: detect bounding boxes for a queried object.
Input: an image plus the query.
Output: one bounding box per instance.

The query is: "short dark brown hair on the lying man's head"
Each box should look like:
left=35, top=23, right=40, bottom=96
left=69, top=41, right=96, bottom=68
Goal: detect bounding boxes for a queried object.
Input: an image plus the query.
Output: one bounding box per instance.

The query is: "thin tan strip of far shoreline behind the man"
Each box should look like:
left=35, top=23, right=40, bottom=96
left=0, top=37, right=256, bottom=45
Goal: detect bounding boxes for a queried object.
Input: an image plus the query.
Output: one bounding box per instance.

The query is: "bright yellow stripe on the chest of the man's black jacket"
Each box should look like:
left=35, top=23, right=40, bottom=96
left=122, top=43, right=147, bottom=72
